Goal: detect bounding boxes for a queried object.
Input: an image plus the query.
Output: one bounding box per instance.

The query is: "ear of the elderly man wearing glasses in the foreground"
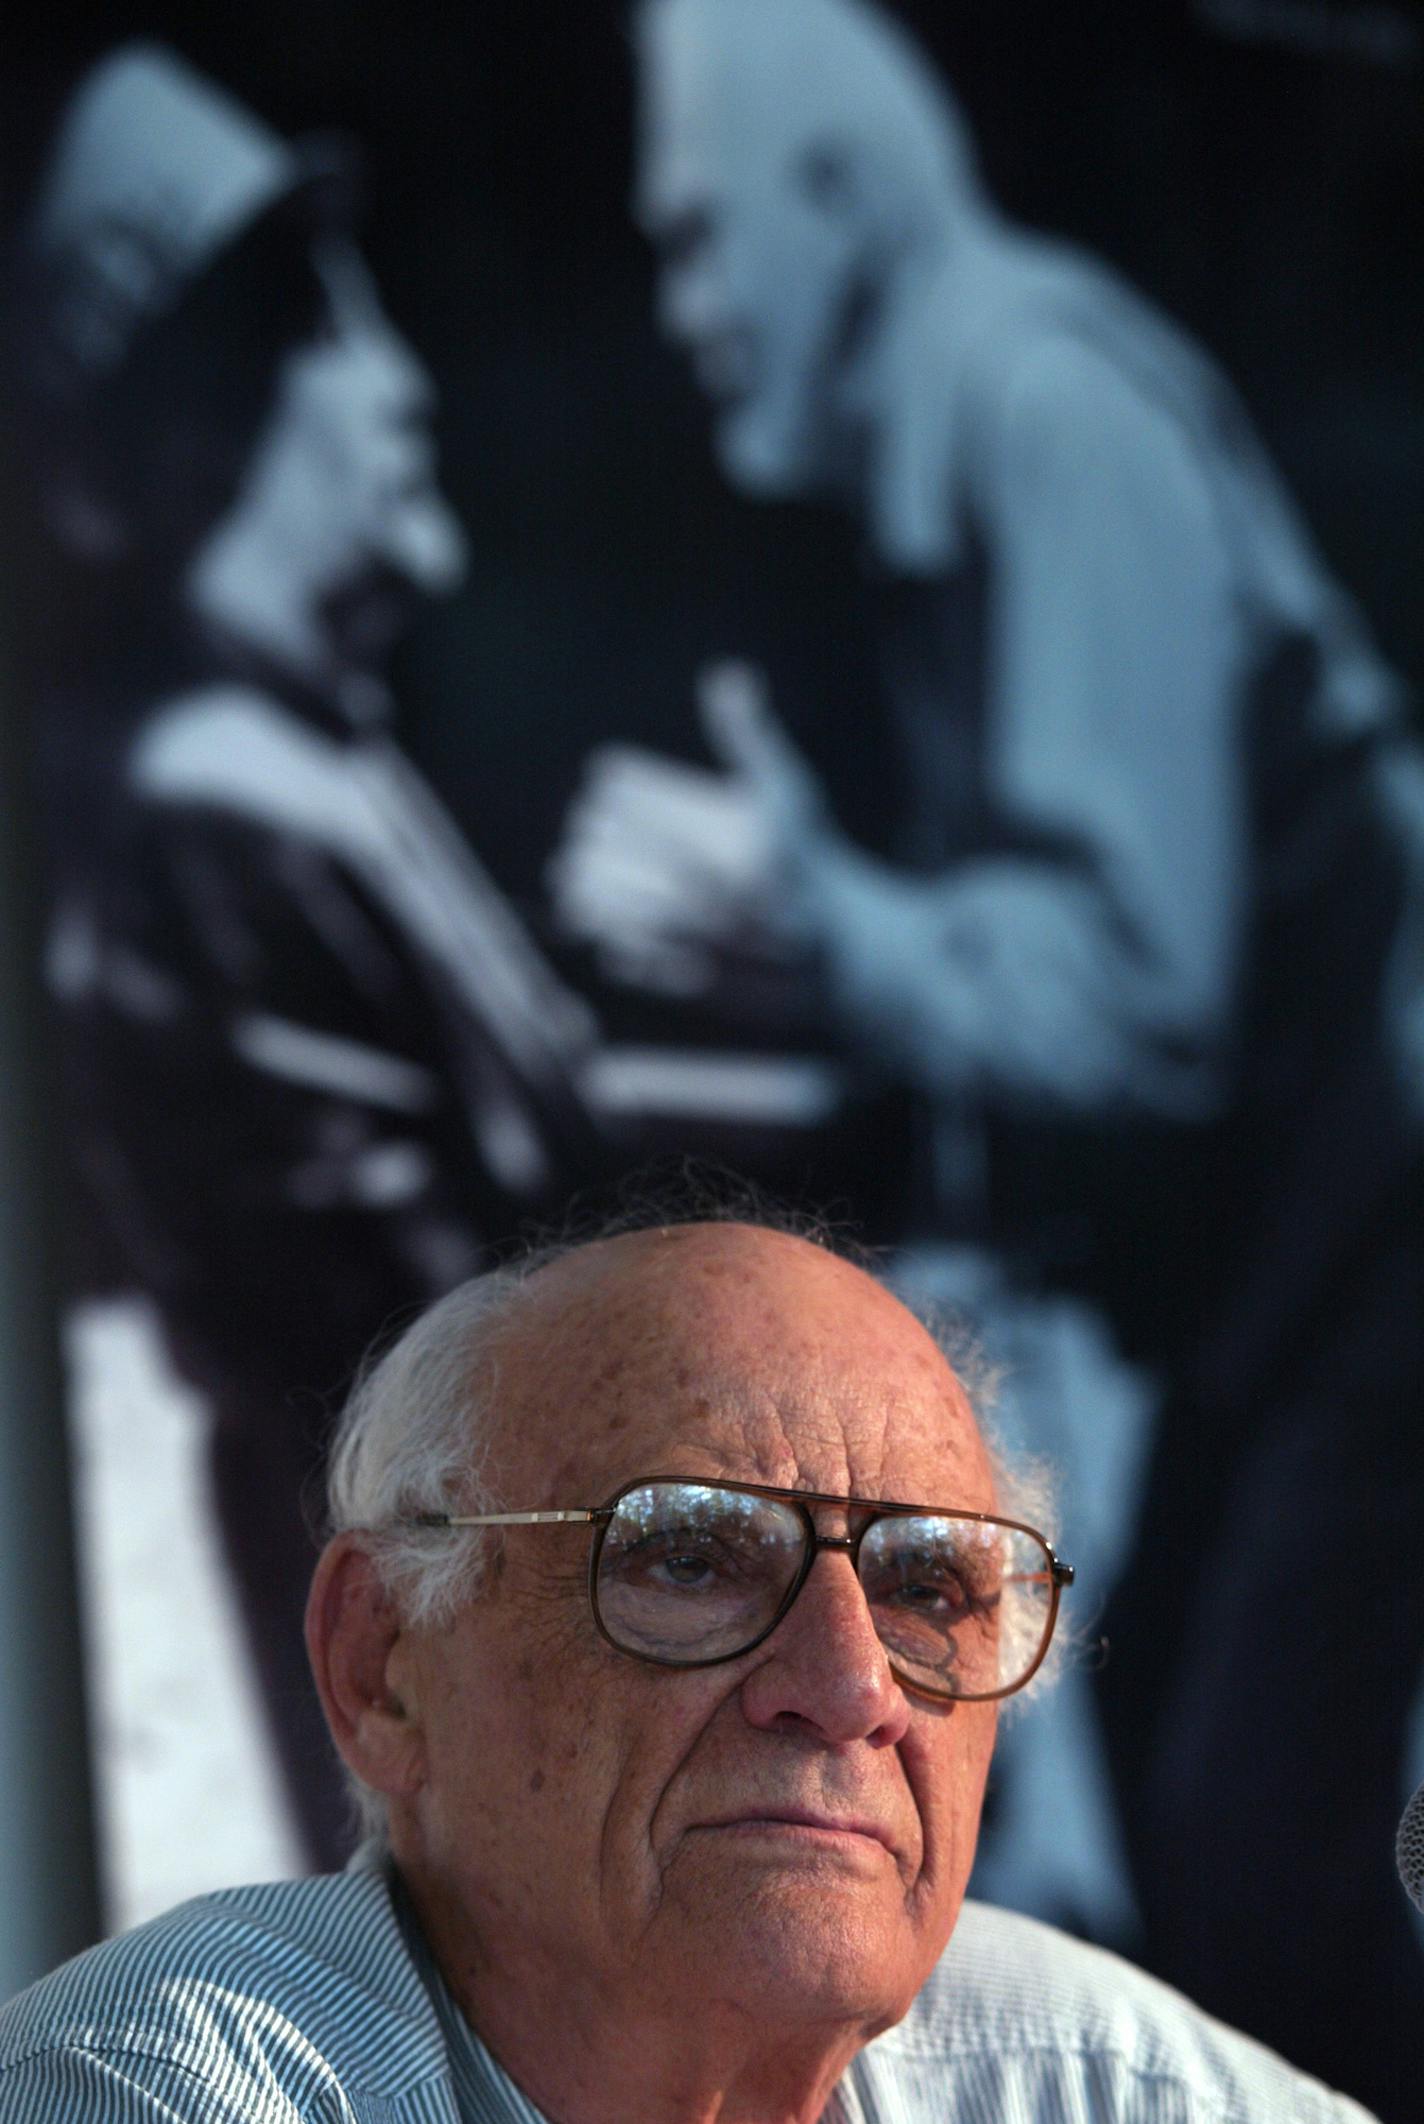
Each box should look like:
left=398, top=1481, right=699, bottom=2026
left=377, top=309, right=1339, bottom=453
left=306, top=1534, right=425, bottom=1799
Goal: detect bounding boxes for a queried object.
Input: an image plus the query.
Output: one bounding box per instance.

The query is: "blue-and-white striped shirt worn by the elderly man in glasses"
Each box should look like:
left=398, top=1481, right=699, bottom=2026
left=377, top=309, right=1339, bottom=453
left=0, top=1865, right=1369, bottom=2124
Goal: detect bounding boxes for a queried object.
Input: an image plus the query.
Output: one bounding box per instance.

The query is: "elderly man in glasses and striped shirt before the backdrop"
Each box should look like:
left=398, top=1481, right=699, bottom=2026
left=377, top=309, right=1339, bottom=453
left=0, top=1221, right=1385, bottom=2124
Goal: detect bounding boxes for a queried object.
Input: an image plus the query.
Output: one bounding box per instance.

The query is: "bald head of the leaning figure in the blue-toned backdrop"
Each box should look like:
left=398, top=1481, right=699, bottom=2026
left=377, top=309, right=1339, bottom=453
left=635, top=0, right=982, bottom=499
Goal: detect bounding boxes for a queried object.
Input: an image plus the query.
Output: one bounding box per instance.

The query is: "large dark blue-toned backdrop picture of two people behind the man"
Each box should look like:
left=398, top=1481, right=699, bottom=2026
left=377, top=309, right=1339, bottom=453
left=0, top=0, right=1424, bottom=2120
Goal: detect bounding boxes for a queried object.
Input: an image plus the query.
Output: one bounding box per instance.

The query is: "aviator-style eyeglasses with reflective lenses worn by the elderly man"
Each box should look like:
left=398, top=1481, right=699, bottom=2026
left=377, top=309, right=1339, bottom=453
left=412, top=1476, right=1073, bottom=1703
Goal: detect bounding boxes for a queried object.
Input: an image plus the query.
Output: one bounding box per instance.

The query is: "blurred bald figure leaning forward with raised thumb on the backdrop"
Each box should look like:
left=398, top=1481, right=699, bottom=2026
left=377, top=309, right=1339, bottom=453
left=550, top=0, right=1424, bottom=2111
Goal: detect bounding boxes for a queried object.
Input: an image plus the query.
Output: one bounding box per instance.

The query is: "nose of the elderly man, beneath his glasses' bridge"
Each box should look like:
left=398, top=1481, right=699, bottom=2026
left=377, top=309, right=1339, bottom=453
left=742, top=1548, right=910, bottom=1748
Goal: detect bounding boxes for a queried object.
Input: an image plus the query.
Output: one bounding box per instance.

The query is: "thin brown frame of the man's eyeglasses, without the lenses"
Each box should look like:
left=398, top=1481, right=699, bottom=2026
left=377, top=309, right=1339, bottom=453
left=406, top=1474, right=1073, bottom=1703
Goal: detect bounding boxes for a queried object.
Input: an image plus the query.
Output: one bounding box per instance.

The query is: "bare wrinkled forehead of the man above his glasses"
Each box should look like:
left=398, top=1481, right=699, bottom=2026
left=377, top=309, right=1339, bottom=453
left=484, top=1226, right=993, bottom=1508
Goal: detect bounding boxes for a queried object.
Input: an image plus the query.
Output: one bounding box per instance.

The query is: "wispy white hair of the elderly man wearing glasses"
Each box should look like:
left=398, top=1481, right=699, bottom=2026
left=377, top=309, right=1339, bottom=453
left=327, top=1198, right=1063, bottom=1846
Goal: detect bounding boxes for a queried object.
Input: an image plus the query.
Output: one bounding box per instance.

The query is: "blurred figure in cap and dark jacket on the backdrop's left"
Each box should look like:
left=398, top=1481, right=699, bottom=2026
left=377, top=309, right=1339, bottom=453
left=15, top=45, right=612, bottom=1859
